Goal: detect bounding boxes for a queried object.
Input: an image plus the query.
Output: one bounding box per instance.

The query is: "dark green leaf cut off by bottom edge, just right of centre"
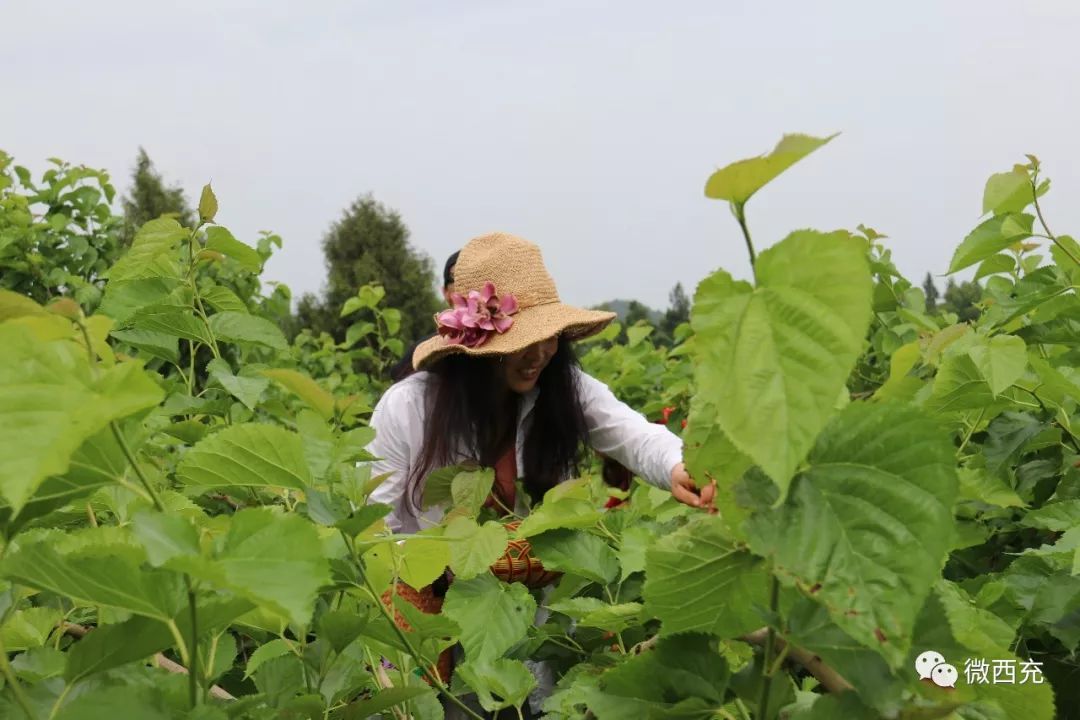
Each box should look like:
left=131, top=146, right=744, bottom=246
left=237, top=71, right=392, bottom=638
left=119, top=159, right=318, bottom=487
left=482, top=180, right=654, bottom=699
left=586, top=635, right=730, bottom=720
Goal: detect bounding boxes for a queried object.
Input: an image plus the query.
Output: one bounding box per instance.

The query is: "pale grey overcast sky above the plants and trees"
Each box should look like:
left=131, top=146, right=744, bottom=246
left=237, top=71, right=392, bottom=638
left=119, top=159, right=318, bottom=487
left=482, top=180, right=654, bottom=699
left=0, top=0, right=1080, bottom=308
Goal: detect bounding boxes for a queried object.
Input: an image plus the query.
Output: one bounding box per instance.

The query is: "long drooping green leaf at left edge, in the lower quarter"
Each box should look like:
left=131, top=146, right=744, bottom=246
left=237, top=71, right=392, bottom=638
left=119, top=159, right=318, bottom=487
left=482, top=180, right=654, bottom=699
left=0, top=541, right=184, bottom=622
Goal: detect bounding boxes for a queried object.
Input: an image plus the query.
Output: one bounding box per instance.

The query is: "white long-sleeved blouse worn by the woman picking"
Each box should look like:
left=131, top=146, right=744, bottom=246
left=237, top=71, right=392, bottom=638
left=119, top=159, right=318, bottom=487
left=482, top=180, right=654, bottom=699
left=367, top=370, right=683, bottom=532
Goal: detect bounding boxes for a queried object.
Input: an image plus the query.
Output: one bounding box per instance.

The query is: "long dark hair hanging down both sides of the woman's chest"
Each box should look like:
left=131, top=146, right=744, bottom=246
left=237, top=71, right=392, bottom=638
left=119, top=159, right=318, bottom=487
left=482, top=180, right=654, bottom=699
left=407, top=338, right=589, bottom=507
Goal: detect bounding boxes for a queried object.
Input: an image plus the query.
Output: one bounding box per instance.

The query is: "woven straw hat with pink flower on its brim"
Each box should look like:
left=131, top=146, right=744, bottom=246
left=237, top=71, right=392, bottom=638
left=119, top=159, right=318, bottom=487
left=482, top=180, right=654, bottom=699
left=413, top=232, right=616, bottom=369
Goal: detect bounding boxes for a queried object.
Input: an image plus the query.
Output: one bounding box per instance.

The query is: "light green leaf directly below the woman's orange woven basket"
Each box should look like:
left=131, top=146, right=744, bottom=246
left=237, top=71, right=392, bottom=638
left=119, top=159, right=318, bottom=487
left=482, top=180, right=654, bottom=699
left=443, top=573, right=537, bottom=662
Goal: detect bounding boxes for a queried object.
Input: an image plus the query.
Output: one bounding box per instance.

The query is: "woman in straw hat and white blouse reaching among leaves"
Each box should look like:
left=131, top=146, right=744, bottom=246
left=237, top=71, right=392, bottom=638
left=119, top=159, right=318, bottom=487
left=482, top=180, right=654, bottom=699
left=368, top=233, right=715, bottom=532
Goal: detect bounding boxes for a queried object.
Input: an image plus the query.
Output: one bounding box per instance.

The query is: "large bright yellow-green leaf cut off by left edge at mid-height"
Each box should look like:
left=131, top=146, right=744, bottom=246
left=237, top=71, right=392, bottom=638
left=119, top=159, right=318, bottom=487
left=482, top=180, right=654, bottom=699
left=0, top=323, right=162, bottom=514
